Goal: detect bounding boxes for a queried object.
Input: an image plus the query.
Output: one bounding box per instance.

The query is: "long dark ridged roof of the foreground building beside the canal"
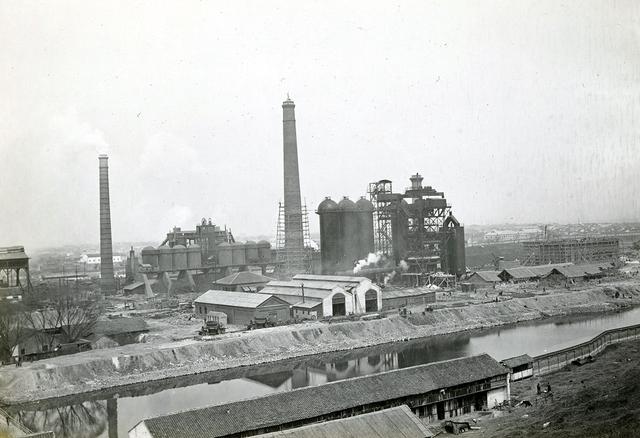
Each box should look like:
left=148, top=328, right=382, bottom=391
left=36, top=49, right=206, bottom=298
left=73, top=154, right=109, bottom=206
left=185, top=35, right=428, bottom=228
left=138, top=354, right=508, bottom=438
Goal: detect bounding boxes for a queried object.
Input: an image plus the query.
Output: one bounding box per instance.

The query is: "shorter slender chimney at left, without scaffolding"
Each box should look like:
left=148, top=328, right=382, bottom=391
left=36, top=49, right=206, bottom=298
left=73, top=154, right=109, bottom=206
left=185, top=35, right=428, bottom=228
left=98, top=154, right=116, bottom=295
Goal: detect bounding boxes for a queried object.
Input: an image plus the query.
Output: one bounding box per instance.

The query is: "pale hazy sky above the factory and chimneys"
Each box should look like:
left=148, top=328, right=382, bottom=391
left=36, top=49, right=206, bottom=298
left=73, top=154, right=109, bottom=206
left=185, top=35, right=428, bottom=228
left=0, top=0, right=640, bottom=248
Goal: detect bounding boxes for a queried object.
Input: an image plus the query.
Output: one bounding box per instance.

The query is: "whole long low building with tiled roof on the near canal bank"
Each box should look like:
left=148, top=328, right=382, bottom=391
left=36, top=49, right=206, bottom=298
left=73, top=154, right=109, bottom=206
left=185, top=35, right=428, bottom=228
left=129, top=354, right=510, bottom=438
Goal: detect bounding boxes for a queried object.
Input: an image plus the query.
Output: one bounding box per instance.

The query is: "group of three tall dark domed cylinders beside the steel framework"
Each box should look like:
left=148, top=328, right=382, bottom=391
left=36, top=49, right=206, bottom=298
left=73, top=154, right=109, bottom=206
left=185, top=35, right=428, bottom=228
left=316, top=196, right=374, bottom=274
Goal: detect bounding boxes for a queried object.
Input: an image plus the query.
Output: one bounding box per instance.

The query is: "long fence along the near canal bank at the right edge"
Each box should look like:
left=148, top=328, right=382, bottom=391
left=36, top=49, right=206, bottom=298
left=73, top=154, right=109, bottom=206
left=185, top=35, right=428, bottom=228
left=533, top=324, right=640, bottom=376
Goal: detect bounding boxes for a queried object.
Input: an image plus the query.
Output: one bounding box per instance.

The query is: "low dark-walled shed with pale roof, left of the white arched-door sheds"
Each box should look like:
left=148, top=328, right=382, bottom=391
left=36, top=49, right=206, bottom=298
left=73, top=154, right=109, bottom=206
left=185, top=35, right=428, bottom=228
left=193, top=290, right=289, bottom=325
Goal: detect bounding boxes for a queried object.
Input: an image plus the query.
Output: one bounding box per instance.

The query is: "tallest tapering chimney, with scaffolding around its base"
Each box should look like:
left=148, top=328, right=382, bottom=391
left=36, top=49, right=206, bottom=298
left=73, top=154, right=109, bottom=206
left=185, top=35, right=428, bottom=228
left=282, top=95, right=304, bottom=266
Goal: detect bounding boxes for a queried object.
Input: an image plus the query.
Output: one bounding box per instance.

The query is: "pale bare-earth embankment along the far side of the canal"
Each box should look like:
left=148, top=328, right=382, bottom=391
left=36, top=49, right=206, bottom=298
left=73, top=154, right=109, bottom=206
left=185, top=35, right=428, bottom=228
left=0, top=281, right=640, bottom=404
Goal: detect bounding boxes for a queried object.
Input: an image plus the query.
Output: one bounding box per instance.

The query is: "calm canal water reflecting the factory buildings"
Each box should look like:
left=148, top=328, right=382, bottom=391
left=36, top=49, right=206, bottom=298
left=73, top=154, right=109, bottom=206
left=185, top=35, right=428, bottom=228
left=12, top=308, right=640, bottom=438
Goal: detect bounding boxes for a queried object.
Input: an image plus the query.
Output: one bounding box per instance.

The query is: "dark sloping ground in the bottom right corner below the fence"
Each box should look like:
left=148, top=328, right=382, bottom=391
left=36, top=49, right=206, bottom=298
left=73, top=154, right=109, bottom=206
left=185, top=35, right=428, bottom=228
left=464, top=340, right=640, bottom=438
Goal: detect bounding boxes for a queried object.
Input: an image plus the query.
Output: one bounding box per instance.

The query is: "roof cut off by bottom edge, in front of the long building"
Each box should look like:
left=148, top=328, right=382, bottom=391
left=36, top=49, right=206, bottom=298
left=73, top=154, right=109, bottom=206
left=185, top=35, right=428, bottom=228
left=257, top=405, right=433, bottom=438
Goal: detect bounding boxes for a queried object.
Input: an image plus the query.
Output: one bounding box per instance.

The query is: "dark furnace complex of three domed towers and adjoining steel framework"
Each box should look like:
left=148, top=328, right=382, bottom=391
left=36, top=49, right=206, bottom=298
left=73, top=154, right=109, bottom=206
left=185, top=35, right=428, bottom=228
left=317, top=174, right=466, bottom=276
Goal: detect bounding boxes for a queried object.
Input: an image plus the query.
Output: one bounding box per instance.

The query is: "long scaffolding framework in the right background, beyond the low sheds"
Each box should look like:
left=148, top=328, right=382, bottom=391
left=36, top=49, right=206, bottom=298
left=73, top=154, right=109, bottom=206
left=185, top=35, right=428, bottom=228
left=523, top=237, right=620, bottom=266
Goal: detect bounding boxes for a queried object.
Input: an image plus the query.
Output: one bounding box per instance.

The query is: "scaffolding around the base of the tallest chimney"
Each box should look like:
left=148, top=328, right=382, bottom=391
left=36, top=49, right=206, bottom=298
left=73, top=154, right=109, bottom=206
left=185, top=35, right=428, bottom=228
left=276, top=202, right=312, bottom=277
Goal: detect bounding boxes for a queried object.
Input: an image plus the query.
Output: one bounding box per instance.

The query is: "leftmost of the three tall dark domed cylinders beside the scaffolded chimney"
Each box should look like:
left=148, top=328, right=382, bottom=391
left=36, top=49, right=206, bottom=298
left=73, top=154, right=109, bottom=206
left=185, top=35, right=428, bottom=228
left=316, top=197, right=342, bottom=274
